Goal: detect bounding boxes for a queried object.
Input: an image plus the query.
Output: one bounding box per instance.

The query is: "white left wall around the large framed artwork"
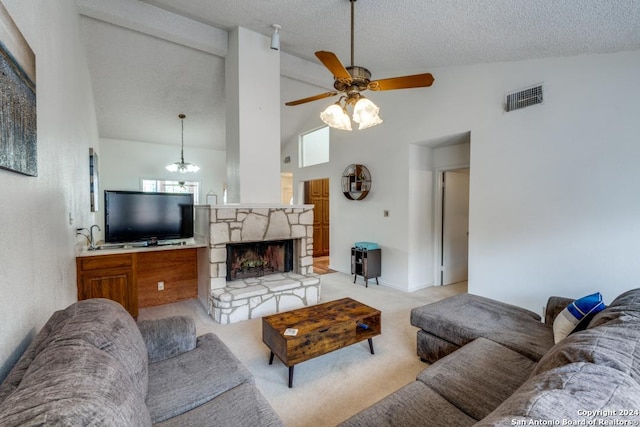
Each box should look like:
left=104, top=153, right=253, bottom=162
left=0, top=0, right=98, bottom=381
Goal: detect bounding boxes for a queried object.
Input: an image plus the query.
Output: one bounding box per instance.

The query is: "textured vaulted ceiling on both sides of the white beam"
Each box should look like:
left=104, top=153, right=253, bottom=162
left=77, top=0, right=640, bottom=149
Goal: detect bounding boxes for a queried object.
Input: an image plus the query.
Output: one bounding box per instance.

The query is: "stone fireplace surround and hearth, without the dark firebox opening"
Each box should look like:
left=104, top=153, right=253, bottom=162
left=196, top=205, right=320, bottom=324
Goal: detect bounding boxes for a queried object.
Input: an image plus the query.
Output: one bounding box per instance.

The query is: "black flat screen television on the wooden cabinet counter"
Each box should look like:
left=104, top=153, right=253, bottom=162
left=104, top=190, right=194, bottom=244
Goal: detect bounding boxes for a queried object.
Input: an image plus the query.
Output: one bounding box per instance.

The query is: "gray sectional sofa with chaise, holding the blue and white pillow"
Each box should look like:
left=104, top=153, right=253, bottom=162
left=341, top=289, right=640, bottom=427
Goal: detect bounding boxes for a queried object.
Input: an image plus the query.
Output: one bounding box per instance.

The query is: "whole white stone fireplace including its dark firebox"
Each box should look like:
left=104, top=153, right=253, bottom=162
left=196, top=205, right=320, bottom=324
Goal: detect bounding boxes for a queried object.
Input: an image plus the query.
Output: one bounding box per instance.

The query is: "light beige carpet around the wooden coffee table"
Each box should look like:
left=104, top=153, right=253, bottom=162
left=138, top=273, right=467, bottom=427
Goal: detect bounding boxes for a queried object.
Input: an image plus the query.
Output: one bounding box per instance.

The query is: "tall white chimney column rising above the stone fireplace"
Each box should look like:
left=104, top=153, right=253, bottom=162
left=225, top=28, right=280, bottom=203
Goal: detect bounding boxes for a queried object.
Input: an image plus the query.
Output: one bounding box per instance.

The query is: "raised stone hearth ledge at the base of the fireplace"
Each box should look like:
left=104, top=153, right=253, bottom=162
left=211, top=273, right=320, bottom=324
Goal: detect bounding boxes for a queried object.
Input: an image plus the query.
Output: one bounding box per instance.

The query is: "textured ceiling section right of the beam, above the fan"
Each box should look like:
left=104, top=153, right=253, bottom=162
left=140, top=0, right=640, bottom=73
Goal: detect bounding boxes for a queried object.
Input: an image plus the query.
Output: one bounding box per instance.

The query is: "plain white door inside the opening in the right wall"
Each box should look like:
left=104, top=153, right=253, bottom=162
left=438, top=168, right=469, bottom=285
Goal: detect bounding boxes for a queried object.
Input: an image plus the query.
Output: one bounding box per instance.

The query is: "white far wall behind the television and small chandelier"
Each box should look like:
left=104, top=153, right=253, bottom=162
left=96, top=138, right=226, bottom=239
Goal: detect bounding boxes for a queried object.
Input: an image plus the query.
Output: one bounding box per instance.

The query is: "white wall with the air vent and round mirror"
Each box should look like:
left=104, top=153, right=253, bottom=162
left=282, top=51, right=640, bottom=312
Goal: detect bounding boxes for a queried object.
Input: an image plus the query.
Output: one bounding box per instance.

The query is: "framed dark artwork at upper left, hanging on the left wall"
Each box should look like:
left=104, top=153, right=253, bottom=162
left=0, top=2, right=38, bottom=176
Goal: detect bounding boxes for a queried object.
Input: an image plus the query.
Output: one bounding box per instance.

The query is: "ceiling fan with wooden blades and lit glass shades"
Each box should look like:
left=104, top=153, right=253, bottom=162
left=285, top=0, right=434, bottom=130
